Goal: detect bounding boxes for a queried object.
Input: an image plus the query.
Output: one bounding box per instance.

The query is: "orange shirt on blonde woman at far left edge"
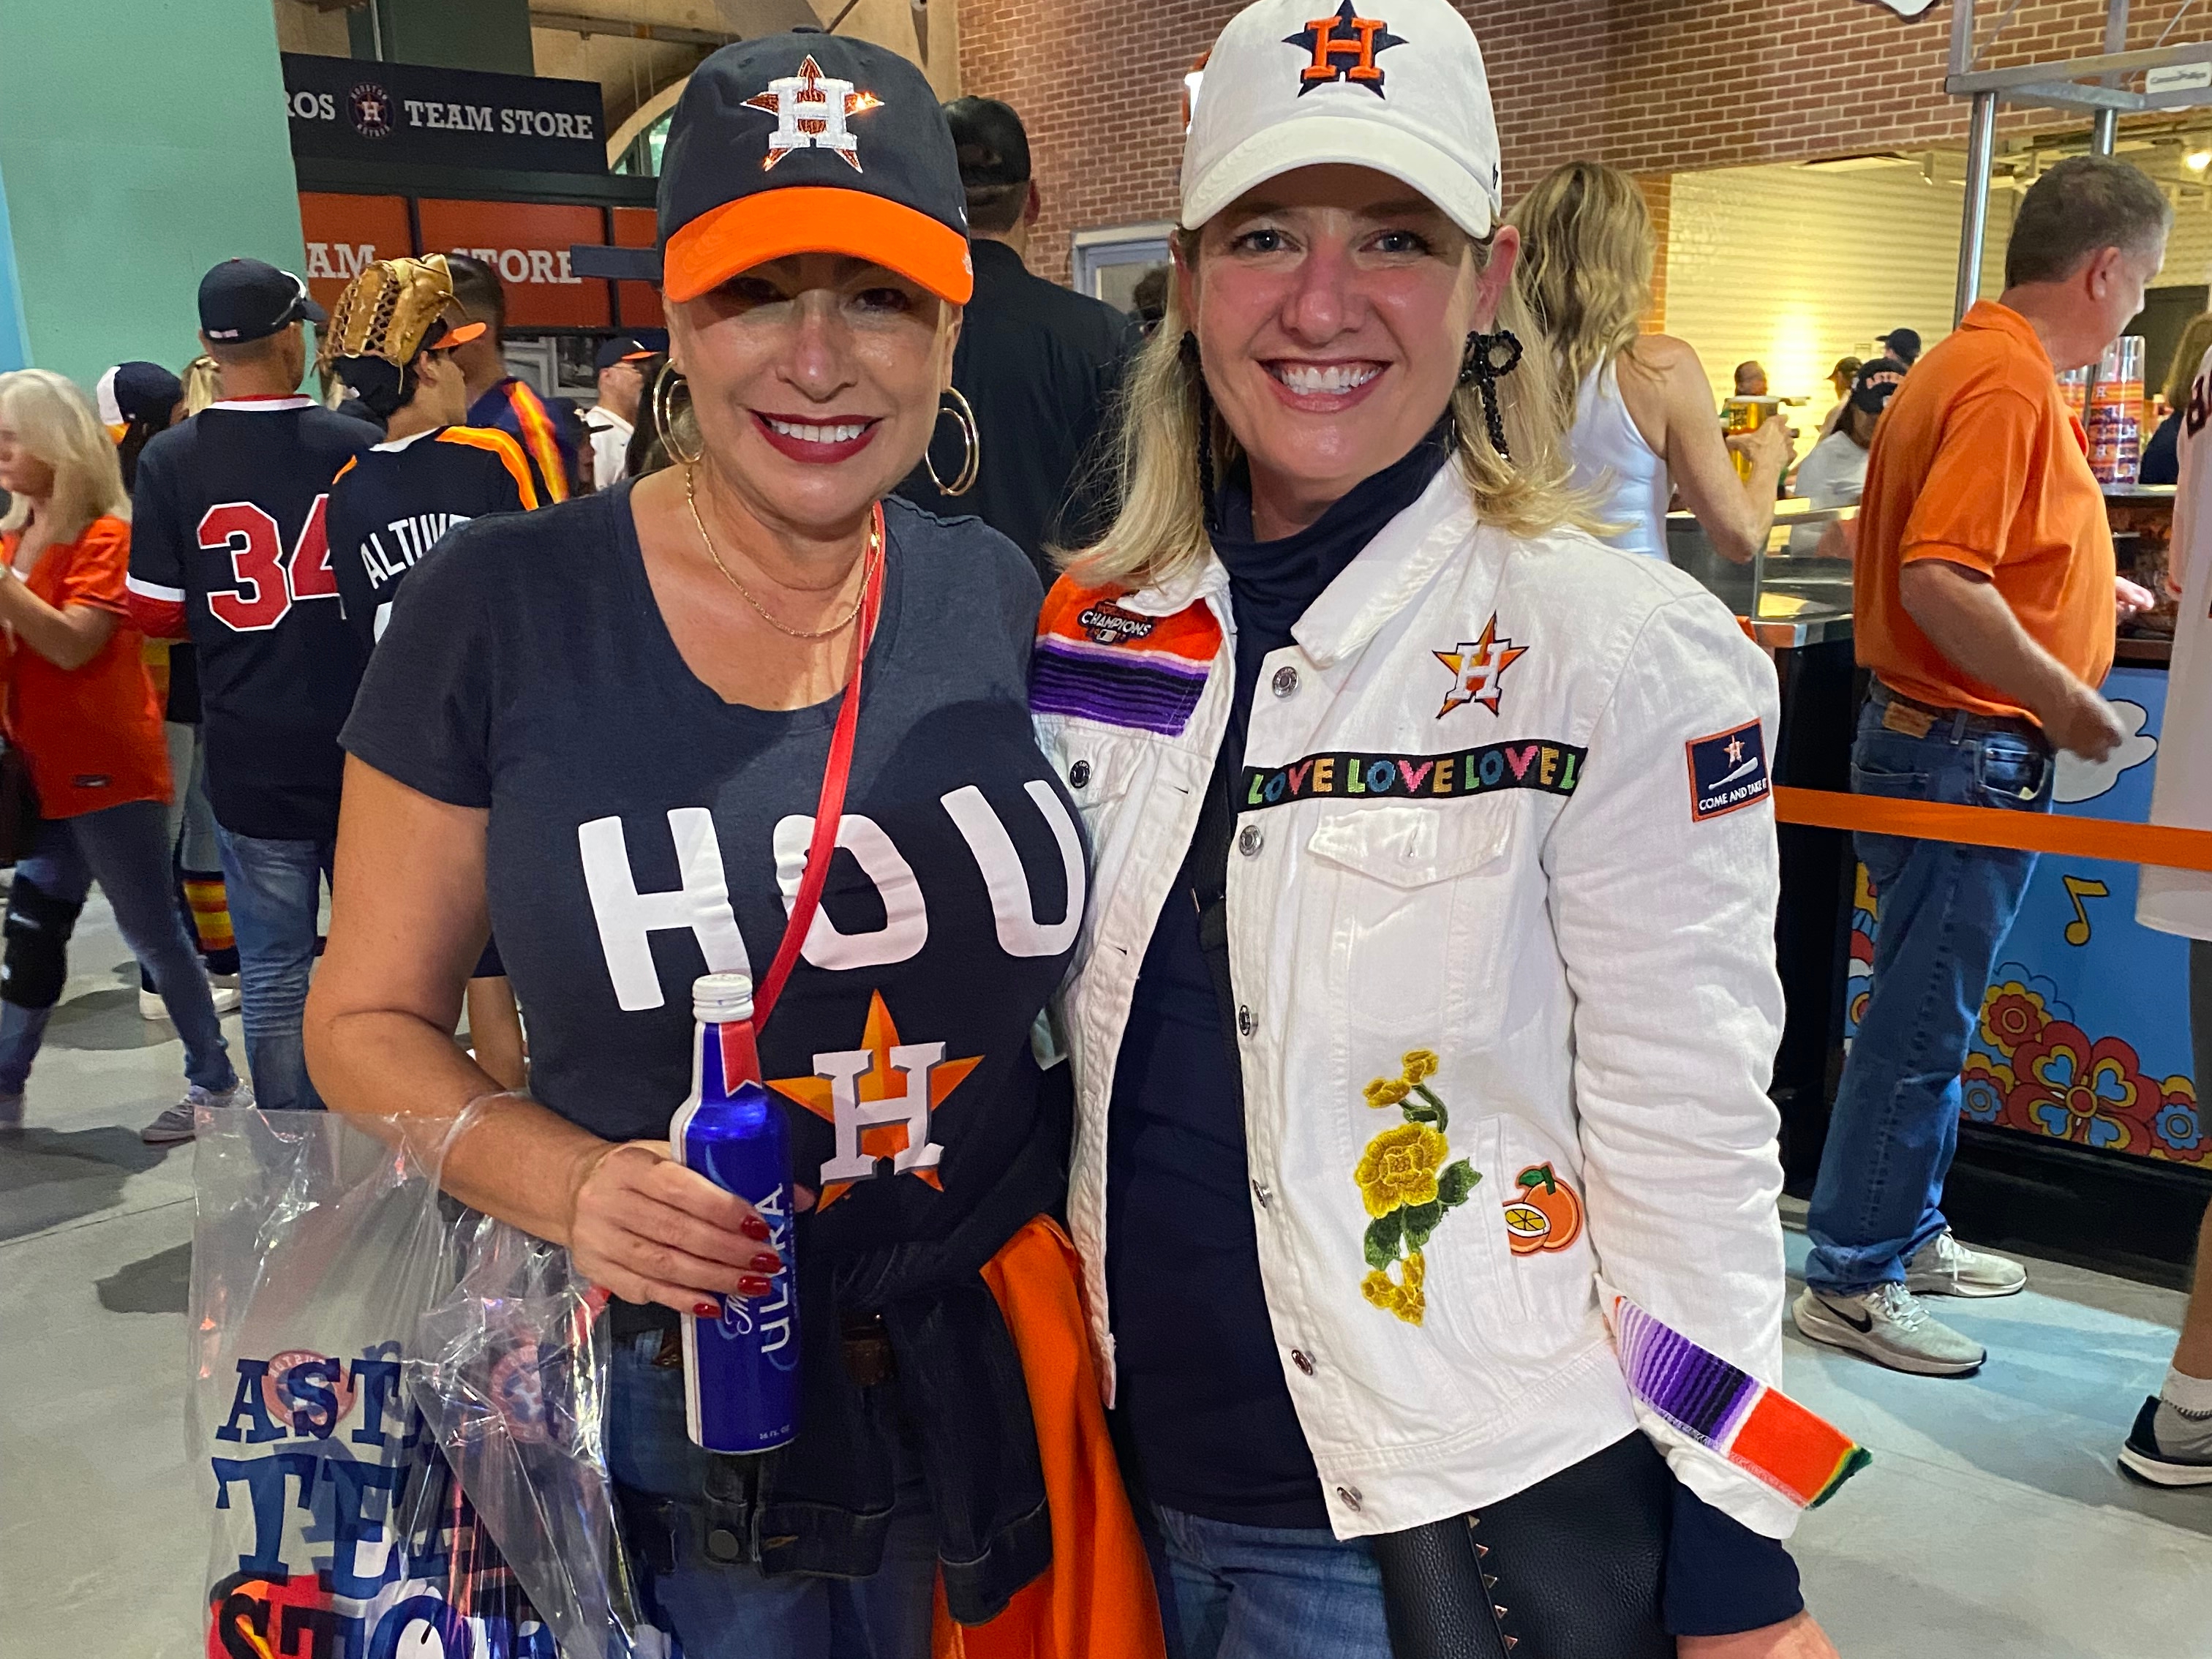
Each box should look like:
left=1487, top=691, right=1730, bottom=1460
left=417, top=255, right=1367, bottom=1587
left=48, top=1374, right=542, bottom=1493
left=0, top=518, right=168, bottom=819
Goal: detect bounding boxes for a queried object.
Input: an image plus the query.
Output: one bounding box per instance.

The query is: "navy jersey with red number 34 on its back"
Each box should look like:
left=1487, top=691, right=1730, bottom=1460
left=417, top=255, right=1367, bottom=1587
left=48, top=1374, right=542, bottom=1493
left=128, top=398, right=378, bottom=840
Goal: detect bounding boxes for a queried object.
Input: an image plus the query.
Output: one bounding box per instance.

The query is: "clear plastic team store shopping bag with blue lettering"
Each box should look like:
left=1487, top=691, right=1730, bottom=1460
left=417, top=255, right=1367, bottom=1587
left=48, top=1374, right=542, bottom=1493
left=188, top=1108, right=674, bottom=1659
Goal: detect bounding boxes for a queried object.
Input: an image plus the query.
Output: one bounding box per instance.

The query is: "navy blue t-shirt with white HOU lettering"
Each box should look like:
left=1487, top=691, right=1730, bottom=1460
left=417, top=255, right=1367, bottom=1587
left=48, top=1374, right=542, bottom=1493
left=343, top=484, right=1088, bottom=1254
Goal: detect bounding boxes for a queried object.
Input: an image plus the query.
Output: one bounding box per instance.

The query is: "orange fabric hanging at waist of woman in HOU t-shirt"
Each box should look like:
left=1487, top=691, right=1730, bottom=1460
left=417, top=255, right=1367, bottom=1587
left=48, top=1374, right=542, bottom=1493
left=931, top=1216, right=1168, bottom=1659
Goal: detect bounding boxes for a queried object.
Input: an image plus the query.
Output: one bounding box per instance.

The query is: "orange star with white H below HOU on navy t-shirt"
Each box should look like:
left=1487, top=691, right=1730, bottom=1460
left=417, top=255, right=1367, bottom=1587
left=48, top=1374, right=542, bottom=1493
left=767, top=991, right=982, bottom=1210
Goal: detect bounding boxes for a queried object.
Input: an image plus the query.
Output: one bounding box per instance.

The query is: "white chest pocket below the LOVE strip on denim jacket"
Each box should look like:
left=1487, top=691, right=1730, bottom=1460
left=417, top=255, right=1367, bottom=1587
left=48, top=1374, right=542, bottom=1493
left=1301, top=799, right=1519, bottom=1053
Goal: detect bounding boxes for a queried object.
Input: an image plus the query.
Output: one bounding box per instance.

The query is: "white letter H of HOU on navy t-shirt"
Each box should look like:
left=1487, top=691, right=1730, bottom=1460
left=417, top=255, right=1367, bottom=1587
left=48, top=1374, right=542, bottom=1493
left=575, top=808, right=752, bottom=1013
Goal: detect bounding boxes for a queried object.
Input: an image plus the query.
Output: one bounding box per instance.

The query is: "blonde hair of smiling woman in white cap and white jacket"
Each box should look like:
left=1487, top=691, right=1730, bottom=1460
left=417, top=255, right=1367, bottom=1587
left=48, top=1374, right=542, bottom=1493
left=1055, top=230, right=1590, bottom=586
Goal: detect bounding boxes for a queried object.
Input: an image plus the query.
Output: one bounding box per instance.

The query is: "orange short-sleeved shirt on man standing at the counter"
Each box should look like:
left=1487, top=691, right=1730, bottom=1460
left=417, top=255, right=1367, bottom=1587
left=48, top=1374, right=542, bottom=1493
left=1851, top=298, right=2117, bottom=719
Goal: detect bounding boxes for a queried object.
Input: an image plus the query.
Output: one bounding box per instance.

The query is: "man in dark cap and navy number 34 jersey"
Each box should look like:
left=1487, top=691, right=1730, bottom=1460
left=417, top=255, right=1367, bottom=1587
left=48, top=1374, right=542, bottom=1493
left=128, top=259, right=380, bottom=1137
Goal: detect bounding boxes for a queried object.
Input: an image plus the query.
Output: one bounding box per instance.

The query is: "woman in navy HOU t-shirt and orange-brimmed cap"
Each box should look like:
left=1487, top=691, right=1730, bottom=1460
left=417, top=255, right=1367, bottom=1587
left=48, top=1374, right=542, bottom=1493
left=307, top=33, right=1162, bottom=1659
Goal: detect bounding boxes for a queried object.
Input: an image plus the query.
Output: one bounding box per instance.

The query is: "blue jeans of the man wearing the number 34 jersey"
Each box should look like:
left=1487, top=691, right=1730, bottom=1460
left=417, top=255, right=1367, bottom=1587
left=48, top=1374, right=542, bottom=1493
left=214, top=825, right=336, bottom=1113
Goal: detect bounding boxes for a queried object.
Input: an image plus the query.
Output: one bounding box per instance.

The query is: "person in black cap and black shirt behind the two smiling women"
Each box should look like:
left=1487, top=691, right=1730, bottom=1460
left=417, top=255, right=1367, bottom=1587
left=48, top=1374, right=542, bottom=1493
left=898, top=97, right=1137, bottom=582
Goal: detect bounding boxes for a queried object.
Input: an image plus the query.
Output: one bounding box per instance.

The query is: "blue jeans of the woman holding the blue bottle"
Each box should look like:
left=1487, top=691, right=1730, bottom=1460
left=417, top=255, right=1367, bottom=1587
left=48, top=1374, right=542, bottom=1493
left=606, top=1331, right=938, bottom=1659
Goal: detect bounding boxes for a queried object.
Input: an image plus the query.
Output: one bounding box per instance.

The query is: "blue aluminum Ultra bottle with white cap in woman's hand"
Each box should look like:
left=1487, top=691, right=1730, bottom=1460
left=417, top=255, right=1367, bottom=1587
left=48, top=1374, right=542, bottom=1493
left=668, top=974, right=799, bottom=1453
